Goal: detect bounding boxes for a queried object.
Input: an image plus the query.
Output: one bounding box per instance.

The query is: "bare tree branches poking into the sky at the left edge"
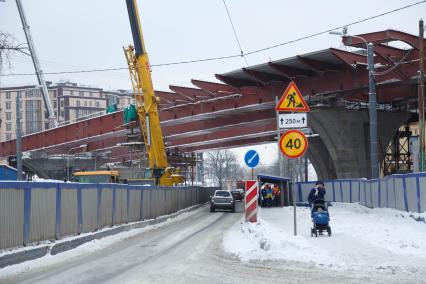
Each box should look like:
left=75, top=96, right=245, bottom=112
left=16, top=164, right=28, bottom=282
left=0, top=31, right=30, bottom=72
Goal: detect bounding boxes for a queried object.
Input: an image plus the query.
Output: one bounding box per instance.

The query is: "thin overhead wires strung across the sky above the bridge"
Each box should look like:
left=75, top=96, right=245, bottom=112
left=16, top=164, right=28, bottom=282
left=0, top=0, right=426, bottom=76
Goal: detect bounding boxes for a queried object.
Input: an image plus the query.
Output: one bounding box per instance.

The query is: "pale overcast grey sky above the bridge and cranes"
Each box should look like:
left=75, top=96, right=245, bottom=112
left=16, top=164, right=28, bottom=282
left=0, top=0, right=426, bottom=90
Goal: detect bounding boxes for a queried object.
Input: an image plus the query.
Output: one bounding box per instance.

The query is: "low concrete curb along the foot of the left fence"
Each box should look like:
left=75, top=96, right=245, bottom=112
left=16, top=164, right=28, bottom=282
left=0, top=203, right=206, bottom=268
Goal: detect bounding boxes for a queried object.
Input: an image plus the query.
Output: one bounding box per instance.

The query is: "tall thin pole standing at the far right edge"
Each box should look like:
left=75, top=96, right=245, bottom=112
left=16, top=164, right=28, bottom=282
left=418, top=19, right=425, bottom=172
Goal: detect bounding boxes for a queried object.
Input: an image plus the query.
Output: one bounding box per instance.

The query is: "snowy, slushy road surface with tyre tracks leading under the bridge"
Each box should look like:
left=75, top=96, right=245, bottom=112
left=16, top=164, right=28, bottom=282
left=0, top=203, right=419, bottom=284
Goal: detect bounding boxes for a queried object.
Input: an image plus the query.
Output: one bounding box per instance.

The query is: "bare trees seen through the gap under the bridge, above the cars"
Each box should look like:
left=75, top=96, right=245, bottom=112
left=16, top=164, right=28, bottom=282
left=206, top=150, right=243, bottom=187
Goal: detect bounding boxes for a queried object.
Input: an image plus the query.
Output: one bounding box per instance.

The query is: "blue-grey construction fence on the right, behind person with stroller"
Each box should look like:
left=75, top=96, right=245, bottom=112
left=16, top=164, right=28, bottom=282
left=294, top=173, right=426, bottom=213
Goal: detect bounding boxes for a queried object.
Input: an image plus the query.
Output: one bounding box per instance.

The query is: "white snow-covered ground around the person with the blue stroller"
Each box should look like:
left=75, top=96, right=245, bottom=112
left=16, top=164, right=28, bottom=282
left=223, top=203, right=426, bottom=275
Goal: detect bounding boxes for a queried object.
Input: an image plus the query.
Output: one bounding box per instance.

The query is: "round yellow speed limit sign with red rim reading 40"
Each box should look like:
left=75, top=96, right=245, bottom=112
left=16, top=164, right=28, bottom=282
left=280, top=130, right=308, bottom=159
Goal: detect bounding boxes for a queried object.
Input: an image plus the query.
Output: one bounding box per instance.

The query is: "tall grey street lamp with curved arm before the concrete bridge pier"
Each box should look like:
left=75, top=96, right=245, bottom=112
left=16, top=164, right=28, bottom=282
left=330, top=28, right=379, bottom=179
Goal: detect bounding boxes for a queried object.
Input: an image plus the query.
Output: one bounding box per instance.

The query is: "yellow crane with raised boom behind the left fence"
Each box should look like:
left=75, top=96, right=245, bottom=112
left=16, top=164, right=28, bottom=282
left=123, top=0, right=183, bottom=186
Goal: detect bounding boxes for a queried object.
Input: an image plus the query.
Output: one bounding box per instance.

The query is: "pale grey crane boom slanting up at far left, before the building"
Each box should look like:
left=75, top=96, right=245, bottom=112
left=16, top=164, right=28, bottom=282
left=16, top=0, right=58, bottom=128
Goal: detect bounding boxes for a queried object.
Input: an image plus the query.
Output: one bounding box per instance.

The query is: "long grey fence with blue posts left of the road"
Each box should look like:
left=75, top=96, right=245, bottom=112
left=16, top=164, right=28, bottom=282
left=0, top=182, right=216, bottom=250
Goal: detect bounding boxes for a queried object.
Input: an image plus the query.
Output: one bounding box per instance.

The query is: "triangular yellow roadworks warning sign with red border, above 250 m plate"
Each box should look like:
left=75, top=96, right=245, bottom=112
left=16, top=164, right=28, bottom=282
left=275, top=81, right=309, bottom=112
